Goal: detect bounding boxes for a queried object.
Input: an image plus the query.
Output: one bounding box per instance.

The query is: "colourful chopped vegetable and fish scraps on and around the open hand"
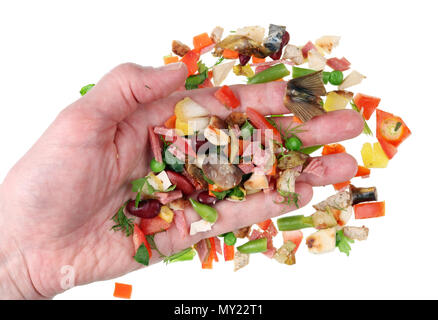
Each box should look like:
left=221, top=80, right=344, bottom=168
left=81, top=24, right=411, bottom=270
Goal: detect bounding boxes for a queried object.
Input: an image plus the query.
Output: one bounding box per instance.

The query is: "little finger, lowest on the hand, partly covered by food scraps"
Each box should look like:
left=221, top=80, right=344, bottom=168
left=155, top=183, right=313, bottom=255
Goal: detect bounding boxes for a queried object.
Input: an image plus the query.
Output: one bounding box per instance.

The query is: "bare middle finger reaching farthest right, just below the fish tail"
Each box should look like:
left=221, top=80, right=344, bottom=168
left=272, top=110, right=363, bottom=146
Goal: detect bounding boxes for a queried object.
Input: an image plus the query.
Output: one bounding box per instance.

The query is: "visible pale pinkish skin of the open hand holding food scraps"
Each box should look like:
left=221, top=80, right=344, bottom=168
left=0, top=64, right=363, bottom=299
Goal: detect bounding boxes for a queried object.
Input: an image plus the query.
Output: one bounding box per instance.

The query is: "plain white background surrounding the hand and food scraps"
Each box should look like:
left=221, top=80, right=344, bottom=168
left=0, top=0, right=438, bottom=299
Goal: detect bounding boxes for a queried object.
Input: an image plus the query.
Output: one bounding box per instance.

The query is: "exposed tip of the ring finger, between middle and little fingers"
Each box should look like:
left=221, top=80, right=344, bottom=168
left=297, top=153, right=357, bottom=186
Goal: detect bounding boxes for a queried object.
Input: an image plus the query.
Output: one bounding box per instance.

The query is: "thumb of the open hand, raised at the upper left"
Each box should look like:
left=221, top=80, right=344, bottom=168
left=79, top=62, right=187, bottom=123
